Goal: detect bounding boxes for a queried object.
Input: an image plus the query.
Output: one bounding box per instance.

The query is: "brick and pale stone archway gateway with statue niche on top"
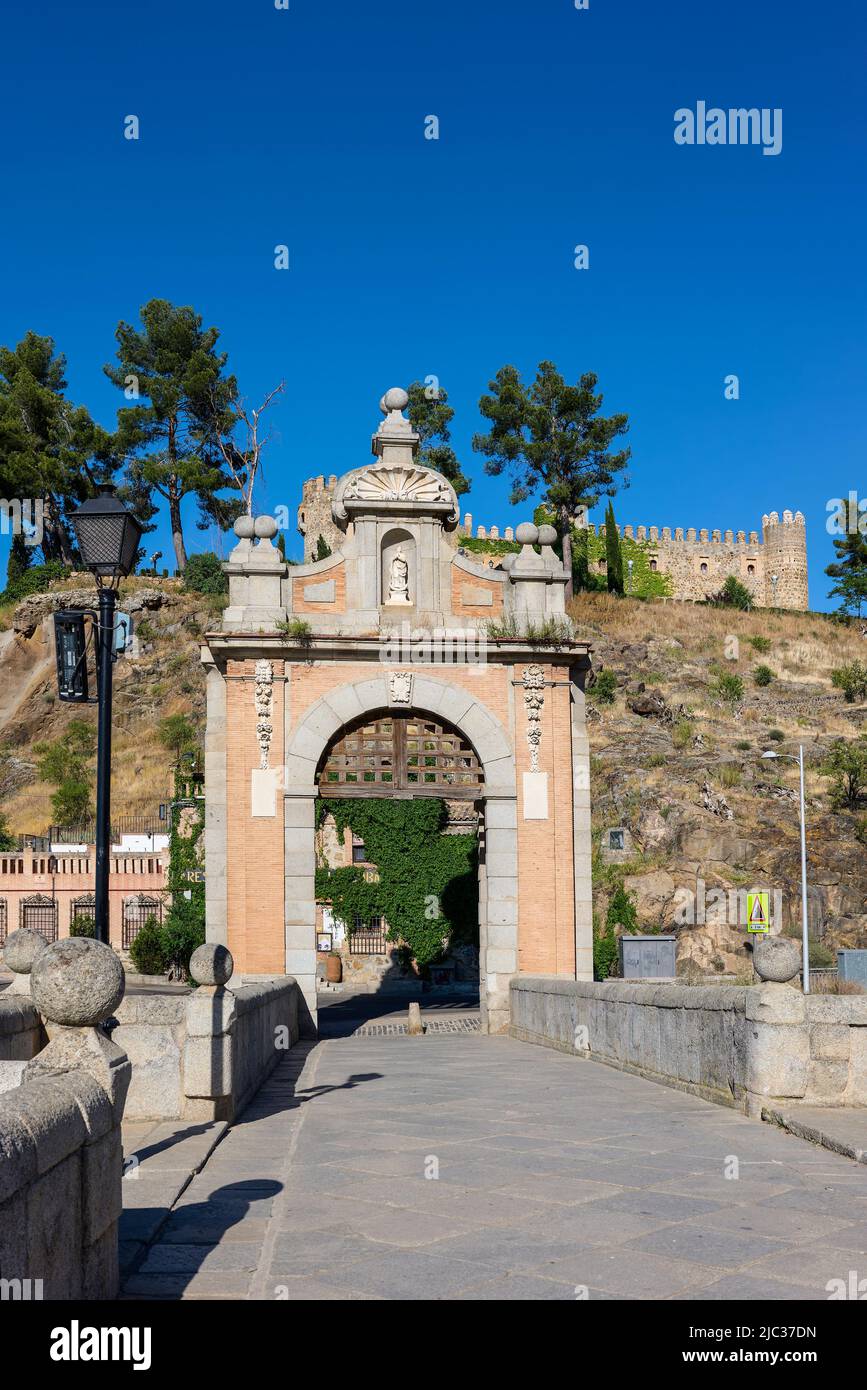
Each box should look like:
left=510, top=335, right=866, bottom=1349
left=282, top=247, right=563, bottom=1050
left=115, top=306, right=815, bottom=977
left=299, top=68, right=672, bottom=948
left=203, top=389, right=592, bottom=1031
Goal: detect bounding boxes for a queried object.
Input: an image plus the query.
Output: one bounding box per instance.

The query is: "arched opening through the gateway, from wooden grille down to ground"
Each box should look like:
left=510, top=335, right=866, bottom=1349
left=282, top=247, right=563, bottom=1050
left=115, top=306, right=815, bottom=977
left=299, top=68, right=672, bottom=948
left=315, top=709, right=485, bottom=1031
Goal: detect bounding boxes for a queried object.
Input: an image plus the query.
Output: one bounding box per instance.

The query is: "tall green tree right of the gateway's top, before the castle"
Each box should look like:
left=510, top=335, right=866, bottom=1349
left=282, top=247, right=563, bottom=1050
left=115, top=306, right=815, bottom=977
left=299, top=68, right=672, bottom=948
left=472, top=361, right=631, bottom=598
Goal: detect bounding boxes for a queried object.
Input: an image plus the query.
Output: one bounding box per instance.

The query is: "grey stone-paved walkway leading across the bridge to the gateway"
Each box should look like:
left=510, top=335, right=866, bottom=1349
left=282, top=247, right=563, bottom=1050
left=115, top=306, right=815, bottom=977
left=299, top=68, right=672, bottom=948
left=118, top=1034, right=867, bottom=1300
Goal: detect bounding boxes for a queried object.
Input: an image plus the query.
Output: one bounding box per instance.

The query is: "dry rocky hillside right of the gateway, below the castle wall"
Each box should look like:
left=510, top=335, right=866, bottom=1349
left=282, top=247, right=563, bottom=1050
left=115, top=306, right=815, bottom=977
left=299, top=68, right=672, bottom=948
left=572, top=595, right=867, bottom=972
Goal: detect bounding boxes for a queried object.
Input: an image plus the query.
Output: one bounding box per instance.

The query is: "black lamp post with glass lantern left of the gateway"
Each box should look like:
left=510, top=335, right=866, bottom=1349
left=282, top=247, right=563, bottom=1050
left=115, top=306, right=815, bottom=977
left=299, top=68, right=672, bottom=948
left=69, top=484, right=142, bottom=945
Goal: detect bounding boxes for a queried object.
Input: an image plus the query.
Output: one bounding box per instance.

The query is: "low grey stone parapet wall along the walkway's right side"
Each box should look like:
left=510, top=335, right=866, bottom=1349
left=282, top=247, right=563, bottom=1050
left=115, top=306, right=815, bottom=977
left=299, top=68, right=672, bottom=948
left=510, top=976, right=867, bottom=1115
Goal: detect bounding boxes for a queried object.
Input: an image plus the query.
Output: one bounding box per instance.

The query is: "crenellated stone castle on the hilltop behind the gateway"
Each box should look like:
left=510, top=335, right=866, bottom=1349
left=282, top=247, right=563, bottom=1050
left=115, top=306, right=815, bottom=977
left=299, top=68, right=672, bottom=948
left=297, top=475, right=809, bottom=613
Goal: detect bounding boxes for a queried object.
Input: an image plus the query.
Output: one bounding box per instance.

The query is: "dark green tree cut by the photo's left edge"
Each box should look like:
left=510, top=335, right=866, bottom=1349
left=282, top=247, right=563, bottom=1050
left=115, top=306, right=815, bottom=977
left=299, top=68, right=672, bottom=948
left=0, top=332, right=118, bottom=564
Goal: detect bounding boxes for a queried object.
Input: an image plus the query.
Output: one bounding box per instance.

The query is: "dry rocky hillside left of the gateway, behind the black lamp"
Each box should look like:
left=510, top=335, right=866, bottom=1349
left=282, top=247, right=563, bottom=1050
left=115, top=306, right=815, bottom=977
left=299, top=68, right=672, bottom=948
left=0, top=575, right=220, bottom=834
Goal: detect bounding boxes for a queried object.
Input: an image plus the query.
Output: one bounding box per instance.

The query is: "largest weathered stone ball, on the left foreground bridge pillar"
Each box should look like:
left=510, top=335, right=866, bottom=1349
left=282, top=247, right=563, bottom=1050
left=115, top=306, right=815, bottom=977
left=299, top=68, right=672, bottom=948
left=31, top=937, right=125, bottom=1027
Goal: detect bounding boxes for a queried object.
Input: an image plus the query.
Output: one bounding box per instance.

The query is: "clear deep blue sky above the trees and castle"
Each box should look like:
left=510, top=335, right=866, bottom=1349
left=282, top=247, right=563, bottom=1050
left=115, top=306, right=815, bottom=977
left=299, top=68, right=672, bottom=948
left=0, top=0, right=867, bottom=607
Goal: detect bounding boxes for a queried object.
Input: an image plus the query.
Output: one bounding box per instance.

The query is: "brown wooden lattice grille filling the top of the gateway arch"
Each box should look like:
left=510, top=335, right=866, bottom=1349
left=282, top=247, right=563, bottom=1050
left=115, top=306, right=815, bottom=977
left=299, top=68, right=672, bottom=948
left=317, top=714, right=484, bottom=798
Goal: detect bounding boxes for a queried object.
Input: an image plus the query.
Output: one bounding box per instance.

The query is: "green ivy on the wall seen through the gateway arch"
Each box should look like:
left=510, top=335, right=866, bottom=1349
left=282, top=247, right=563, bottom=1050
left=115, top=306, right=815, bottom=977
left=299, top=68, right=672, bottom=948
left=315, top=796, right=478, bottom=969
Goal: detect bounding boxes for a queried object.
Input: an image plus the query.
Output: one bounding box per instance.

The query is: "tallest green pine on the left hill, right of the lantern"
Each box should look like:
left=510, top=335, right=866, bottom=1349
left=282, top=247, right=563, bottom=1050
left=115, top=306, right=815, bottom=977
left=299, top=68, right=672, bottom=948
left=104, top=299, right=243, bottom=573
